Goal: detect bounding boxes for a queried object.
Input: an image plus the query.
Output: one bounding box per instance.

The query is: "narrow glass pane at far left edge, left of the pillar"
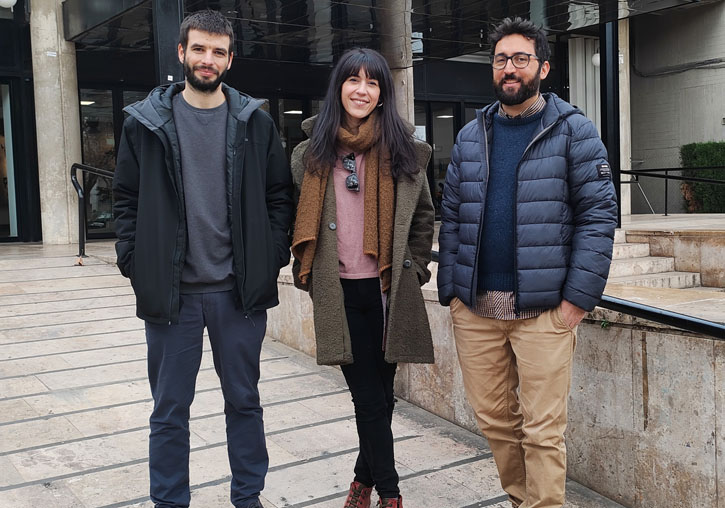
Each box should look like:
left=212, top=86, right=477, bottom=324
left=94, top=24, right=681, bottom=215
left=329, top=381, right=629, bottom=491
left=0, top=84, right=18, bottom=238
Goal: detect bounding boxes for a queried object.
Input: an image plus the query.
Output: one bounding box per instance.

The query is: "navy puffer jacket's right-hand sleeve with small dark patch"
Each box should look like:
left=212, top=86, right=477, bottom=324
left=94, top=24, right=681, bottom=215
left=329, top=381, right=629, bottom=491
left=562, top=115, right=617, bottom=311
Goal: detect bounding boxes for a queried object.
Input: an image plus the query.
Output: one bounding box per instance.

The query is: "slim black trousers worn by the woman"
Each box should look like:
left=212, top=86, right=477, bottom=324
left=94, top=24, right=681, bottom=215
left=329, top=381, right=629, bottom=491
left=341, top=279, right=400, bottom=498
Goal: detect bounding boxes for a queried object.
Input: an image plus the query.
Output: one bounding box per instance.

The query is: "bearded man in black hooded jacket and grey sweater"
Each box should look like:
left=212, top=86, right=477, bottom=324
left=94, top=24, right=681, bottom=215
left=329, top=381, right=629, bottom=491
left=113, top=11, right=293, bottom=508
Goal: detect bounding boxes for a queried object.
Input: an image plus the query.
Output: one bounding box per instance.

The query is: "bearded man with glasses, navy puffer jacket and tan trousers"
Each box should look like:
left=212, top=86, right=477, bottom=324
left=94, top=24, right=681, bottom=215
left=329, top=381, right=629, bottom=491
left=438, top=18, right=617, bottom=508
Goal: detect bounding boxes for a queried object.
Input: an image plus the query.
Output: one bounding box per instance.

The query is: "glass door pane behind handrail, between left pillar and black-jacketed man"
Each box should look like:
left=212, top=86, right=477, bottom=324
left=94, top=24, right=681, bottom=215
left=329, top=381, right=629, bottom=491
left=80, top=89, right=116, bottom=236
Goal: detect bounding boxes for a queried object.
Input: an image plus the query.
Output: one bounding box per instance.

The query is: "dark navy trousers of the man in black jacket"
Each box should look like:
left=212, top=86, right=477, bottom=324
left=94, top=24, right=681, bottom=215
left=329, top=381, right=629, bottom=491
left=146, top=291, right=269, bottom=508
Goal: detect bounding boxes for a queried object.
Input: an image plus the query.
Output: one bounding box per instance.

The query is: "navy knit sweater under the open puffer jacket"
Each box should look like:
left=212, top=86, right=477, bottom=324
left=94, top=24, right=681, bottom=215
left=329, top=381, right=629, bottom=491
left=478, top=111, right=544, bottom=291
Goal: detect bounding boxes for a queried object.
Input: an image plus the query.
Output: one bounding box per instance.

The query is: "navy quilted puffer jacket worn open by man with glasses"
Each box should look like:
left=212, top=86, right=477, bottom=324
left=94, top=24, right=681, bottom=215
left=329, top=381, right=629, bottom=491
left=438, top=94, right=617, bottom=311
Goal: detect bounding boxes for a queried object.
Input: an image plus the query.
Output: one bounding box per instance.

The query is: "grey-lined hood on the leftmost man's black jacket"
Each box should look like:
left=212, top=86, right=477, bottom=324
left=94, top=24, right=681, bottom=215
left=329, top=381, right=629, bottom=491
left=123, top=81, right=264, bottom=130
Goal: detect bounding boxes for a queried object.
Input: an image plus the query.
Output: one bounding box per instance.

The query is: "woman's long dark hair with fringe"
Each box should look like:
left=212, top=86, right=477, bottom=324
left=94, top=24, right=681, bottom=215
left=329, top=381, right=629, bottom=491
left=305, top=48, right=419, bottom=179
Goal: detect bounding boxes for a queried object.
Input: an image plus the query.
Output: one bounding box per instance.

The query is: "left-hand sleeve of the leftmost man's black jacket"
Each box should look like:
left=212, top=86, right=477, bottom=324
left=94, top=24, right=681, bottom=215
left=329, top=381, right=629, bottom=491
left=113, top=117, right=139, bottom=277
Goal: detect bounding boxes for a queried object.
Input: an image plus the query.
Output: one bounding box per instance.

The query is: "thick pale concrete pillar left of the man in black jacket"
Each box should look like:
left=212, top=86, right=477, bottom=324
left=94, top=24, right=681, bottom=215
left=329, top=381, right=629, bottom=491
left=30, top=0, right=81, bottom=244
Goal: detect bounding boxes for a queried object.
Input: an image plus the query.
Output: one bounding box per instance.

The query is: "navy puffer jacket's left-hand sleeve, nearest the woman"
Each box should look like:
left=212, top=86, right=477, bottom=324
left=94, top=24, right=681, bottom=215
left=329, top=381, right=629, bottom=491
left=438, top=133, right=461, bottom=306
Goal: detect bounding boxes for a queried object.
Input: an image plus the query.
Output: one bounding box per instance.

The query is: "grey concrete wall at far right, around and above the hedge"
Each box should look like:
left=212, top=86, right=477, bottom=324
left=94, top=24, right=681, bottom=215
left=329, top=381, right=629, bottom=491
left=631, top=2, right=725, bottom=213
